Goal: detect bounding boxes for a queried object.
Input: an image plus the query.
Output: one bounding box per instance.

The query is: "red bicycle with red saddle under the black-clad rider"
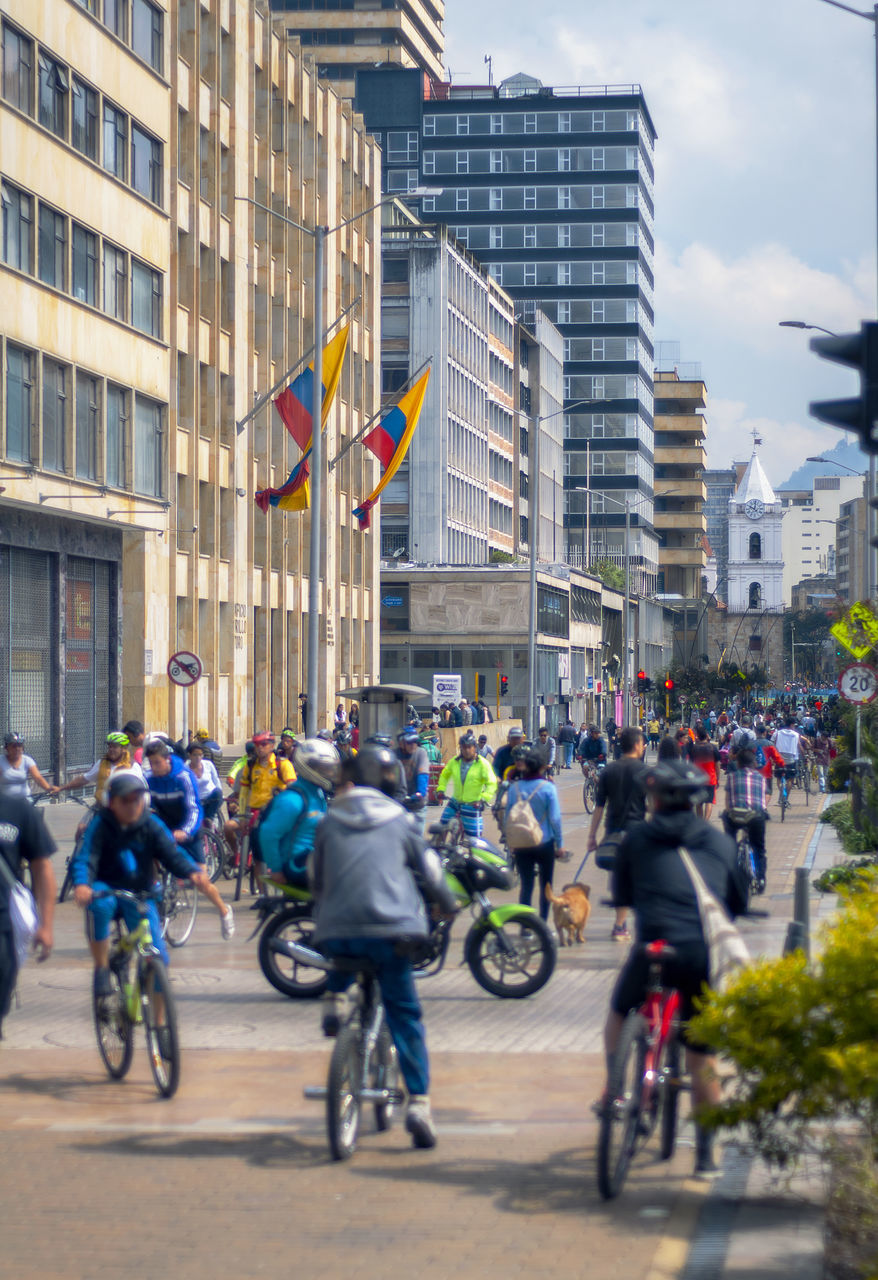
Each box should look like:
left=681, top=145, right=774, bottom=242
left=598, top=942, right=683, bottom=1199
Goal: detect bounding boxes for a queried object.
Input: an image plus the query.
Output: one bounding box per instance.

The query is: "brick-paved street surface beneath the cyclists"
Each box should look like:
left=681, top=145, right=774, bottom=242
left=0, top=771, right=836, bottom=1280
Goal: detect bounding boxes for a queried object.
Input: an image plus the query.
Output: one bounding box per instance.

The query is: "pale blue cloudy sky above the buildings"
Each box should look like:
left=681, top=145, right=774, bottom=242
left=445, top=0, right=878, bottom=484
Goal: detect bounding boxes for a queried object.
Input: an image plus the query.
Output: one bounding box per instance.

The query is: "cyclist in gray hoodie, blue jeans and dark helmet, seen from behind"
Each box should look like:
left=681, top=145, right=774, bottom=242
left=308, top=745, right=457, bottom=1148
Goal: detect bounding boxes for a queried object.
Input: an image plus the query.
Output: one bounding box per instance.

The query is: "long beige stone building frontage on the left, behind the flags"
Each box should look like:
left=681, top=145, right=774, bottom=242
left=0, top=0, right=379, bottom=774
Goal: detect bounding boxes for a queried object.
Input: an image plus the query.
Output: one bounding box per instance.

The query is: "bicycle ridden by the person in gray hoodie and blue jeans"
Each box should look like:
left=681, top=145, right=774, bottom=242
left=295, top=942, right=406, bottom=1160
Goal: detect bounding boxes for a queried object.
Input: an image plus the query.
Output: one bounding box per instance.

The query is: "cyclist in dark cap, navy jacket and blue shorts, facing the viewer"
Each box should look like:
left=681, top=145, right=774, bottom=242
left=72, top=771, right=210, bottom=998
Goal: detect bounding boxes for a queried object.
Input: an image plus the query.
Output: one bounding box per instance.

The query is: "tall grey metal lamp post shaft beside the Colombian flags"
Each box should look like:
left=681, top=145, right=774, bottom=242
left=306, top=225, right=326, bottom=737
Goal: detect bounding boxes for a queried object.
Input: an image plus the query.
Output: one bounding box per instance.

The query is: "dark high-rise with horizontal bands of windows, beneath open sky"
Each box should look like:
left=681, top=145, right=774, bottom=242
left=355, top=69, right=658, bottom=591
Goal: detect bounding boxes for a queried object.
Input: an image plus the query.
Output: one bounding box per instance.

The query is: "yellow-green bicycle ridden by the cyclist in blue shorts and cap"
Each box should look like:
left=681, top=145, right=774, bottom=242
left=92, top=888, right=180, bottom=1098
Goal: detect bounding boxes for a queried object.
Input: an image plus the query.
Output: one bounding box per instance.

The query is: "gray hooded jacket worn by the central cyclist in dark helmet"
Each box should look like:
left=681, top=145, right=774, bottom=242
left=308, top=787, right=456, bottom=942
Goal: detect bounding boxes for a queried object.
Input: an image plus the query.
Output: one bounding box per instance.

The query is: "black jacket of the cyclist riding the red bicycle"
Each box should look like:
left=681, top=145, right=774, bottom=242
left=611, top=809, right=747, bottom=946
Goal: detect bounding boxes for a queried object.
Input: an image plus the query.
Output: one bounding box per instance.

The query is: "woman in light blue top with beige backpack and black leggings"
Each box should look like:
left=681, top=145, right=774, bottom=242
left=504, top=748, right=570, bottom=920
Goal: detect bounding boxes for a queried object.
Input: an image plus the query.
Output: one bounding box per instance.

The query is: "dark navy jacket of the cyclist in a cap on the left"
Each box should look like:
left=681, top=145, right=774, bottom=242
left=72, top=809, right=193, bottom=893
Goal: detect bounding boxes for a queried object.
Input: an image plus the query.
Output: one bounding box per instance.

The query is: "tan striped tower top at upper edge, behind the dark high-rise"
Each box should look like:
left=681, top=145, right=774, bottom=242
left=271, top=0, right=445, bottom=97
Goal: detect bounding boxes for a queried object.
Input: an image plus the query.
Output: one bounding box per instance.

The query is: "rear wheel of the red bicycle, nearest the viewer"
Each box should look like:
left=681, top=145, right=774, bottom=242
left=598, top=1012, right=646, bottom=1199
